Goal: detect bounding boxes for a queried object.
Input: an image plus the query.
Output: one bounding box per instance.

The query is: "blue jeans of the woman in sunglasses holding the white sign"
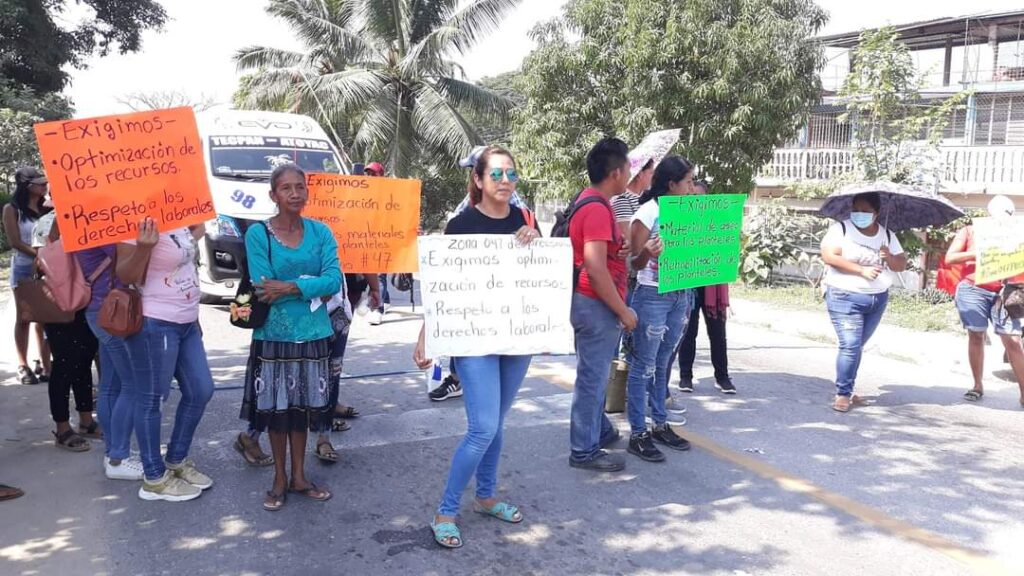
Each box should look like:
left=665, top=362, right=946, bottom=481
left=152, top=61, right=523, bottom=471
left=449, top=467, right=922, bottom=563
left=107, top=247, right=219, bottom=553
left=437, top=355, right=532, bottom=517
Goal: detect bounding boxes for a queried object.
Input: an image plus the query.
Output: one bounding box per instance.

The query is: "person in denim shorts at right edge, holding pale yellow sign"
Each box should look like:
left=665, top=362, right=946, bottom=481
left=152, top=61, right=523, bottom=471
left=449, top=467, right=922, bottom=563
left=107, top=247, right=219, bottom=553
left=946, top=196, right=1024, bottom=406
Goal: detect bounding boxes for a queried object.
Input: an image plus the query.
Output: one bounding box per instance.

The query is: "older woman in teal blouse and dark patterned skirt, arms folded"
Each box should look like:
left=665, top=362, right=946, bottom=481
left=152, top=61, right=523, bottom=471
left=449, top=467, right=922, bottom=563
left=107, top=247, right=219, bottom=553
left=242, top=164, right=341, bottom=510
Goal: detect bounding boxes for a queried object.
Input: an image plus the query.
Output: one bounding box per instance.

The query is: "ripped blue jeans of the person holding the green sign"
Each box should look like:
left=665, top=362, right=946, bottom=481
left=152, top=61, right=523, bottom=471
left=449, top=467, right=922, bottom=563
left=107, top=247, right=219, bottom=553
left=626, top=285, right=693, bottom=434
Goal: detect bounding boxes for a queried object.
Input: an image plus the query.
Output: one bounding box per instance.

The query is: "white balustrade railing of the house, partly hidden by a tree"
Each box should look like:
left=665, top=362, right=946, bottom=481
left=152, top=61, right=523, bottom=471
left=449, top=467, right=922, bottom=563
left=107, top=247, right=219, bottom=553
left=758, top=146, right=1024, bottom=195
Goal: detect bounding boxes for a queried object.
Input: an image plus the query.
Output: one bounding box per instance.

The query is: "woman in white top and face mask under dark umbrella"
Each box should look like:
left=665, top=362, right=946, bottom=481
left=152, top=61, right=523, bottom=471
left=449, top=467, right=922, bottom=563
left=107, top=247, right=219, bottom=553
left=821, top=192, right=906, bottom=412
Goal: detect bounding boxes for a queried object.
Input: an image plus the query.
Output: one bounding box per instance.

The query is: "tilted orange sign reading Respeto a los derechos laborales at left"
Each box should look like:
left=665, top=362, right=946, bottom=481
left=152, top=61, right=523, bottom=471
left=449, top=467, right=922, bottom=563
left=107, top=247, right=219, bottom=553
left=36, top=108, right=214, bottom=251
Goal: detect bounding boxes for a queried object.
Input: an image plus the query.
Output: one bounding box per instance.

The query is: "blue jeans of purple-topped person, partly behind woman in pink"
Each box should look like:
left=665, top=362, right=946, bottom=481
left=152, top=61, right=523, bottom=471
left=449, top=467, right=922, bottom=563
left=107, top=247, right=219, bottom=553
left=85, top=311, right=136, bottom=460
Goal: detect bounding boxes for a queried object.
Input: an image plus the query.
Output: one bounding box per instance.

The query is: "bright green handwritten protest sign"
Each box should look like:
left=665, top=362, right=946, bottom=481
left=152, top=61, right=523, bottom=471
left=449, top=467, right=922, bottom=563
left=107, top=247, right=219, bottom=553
left=657, top=194, right=746, bottom=294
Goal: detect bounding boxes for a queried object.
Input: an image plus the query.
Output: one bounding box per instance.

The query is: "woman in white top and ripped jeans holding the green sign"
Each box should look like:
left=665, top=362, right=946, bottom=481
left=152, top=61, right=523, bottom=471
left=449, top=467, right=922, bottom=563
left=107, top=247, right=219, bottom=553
left=626, top=156, right=695, bottom=462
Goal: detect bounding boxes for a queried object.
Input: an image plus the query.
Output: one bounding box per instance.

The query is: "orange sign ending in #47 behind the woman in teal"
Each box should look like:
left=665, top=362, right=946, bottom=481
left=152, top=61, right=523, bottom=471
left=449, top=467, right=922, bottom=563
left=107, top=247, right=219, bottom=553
left=304, top=174, right=420, bottom=274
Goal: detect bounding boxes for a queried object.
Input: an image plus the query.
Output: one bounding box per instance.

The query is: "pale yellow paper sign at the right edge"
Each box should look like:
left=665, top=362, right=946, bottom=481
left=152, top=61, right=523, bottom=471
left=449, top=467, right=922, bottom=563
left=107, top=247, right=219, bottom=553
left=974, top=216, right=1024, bottom=284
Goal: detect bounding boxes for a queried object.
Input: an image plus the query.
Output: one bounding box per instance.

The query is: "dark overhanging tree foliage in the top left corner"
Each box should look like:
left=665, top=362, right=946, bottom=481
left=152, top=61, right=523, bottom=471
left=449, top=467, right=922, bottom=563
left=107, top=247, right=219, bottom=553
left=0, top=0, right=167, bottom=93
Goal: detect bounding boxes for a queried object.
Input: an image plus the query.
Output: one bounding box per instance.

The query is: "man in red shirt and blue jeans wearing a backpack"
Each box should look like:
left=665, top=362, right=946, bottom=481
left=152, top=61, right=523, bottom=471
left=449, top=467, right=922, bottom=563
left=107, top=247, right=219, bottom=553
left=569, top=138, right=637, bottom=471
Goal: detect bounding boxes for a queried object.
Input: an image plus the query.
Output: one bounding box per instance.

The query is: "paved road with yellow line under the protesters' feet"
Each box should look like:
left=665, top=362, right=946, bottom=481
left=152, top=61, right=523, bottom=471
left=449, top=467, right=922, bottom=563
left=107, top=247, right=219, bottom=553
left=0, top=291, right=1024, bottom=576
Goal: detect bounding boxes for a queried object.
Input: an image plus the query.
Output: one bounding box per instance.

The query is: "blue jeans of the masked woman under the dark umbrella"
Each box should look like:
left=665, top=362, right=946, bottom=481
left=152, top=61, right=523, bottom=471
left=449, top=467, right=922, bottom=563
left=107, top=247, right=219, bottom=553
left=825, top=287, right=889, bottom=396
